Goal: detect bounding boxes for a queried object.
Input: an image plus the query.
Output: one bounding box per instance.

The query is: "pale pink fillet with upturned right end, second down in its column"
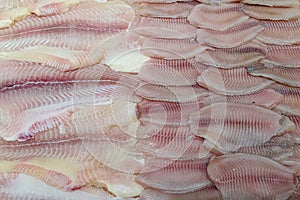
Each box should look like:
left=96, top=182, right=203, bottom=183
left=197, top=19, right=264, bottom=48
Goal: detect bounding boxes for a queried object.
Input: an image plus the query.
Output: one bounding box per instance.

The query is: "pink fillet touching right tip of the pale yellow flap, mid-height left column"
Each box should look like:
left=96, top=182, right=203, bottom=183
left=139, top=59, right=207, bottom=86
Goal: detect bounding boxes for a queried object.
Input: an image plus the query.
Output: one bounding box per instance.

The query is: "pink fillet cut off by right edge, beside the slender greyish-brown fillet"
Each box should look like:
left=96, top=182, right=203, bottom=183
left=264, top=45, right=300, bottom=67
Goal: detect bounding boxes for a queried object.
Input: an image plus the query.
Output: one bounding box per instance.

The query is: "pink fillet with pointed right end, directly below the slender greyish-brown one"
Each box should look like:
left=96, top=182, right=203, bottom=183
left=197, top=67, right=274, bottom=95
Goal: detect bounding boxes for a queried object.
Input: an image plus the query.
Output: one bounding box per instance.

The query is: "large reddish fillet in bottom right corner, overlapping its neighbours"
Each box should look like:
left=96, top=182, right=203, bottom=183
left=207, top=154, right=296, bottom=200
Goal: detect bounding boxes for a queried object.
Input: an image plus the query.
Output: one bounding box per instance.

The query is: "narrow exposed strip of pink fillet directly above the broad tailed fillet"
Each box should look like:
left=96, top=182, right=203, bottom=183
left=202, top=89, right=283, bottom=108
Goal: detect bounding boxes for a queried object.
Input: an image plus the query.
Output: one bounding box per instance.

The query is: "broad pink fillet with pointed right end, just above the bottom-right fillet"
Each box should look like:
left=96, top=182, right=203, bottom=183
left=190, top=103, right=295, bottom=154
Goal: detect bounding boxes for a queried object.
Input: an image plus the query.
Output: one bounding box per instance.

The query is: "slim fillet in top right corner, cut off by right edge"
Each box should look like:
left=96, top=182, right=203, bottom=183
left=241, top=5, right=300, bottom=20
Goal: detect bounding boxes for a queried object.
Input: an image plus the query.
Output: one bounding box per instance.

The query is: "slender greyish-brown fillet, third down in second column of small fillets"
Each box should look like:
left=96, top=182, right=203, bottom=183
left=196, top=44, right=266, bottom=69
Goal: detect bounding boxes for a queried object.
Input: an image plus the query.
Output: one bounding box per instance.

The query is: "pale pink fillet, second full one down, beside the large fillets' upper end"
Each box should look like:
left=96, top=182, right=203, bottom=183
left=134, top=17, right=197, bottom=39
